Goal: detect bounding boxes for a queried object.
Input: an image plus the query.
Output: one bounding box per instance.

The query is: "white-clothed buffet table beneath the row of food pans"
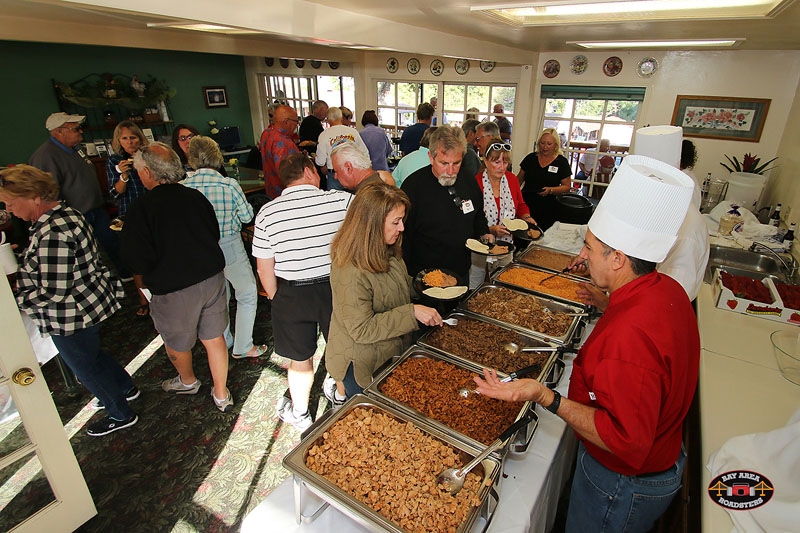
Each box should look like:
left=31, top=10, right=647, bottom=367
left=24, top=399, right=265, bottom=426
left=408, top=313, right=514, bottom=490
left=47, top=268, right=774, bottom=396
left=241, top=354, right=592, bottom=533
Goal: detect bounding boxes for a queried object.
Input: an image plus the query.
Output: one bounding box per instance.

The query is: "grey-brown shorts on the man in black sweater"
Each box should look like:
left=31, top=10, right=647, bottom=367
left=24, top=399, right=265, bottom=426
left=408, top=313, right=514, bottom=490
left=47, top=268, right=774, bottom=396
left=150, top=272, right=228, bottom=352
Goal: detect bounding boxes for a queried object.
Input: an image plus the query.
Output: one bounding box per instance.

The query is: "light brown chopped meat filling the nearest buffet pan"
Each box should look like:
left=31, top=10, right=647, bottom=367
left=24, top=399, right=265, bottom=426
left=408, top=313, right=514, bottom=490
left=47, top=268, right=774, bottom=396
left=306, top=407, right=482, bottom=532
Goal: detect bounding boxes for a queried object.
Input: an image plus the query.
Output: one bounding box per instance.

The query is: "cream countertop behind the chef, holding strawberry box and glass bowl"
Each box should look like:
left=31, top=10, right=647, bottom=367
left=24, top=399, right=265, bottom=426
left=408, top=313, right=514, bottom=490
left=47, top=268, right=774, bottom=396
left=697, top=284, right=800, bottom=533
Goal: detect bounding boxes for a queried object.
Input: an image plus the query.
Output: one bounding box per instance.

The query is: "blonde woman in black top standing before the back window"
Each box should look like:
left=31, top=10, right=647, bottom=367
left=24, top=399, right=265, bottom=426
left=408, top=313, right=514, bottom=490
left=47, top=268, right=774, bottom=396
left=517, top=128, right=572, bottom=230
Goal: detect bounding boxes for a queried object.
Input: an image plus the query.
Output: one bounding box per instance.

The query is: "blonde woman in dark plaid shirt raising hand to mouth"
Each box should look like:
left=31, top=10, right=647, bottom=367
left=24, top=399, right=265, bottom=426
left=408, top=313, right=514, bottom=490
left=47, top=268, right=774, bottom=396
left=106, top=120, right=150, bottom=318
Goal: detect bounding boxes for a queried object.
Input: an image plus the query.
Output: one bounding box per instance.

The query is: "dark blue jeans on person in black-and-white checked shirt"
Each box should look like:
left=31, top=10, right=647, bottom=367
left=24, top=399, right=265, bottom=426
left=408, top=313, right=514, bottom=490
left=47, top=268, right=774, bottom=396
left=51, top=324, right=134, bottom=420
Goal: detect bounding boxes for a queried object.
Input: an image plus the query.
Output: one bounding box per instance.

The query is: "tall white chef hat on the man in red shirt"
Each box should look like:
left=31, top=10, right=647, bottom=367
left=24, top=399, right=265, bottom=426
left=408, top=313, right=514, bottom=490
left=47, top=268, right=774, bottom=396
left=589, top=155, right=694, bottom=263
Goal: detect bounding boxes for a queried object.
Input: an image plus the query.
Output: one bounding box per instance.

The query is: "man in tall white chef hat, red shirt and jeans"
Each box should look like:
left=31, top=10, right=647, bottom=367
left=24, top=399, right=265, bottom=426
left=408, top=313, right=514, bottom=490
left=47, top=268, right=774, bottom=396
left=476, top=156, right=700, bottom=532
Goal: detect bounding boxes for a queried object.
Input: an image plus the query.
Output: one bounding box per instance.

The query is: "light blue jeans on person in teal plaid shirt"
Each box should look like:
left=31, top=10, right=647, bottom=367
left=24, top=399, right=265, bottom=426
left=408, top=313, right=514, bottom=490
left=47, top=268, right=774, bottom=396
left=219, top=233, right=258, bottom=355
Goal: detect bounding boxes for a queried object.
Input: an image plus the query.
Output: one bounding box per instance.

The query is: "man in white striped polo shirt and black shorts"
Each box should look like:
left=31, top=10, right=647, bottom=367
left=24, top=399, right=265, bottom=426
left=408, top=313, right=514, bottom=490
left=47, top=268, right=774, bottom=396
left=253, top=154, right=353, bottom=431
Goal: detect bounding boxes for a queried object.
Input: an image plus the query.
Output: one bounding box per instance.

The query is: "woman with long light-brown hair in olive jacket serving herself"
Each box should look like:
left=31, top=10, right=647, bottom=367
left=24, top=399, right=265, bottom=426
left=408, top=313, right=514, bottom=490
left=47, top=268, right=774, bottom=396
left=325, top=183, right=442, bottom=405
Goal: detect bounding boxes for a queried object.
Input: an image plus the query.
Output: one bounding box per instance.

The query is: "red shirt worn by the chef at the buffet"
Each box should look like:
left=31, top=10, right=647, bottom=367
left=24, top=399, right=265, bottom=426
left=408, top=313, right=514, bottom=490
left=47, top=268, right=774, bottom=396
left=569, top=272, right=700, bottom=475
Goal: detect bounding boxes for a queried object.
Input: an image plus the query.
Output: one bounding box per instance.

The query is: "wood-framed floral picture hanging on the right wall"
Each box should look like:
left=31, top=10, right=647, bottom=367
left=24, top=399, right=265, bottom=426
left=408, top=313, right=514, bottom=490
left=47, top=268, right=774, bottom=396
left=672, top=94, right=772, bottom=142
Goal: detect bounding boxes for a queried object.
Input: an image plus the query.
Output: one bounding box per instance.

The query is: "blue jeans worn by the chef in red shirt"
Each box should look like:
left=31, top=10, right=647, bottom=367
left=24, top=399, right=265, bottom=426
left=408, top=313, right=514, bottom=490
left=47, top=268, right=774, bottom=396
left=566, top=443, right=686, bottom=533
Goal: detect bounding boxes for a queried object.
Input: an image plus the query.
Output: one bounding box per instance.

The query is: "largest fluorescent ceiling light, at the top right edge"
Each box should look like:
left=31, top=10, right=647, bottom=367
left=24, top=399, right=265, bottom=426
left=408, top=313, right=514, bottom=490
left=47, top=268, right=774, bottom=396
left=470, top=0, right=793, bottom=25
